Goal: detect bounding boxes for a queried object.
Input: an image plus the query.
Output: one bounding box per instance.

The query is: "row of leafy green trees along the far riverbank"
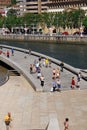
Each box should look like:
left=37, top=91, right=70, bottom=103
left=0, top=9, right=87, bottom=33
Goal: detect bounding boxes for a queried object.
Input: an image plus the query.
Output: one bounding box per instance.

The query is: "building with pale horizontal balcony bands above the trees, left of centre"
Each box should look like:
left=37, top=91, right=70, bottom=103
left=17, top=0, right=48, bottom=15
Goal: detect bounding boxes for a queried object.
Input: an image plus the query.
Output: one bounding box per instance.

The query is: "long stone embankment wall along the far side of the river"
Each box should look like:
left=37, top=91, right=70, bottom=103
left=0, top=34, right=87, bottom=43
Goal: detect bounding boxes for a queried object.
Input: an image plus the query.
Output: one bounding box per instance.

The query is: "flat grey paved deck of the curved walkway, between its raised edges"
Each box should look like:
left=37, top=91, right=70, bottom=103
left=2, top=48, right=87, bottom=92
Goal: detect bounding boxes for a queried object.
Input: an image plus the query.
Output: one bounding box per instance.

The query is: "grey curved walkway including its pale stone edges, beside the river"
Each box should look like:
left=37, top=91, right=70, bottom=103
left=0, top=46, right=87, bottom=92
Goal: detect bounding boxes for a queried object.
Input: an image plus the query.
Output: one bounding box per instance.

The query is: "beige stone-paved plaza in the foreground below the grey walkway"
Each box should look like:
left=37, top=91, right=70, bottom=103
left=0, top=76, right=87, bottom=130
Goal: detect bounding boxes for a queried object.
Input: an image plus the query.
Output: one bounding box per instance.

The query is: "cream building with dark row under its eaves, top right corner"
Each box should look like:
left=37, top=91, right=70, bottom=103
left=47, top=0, right=87, bottom=12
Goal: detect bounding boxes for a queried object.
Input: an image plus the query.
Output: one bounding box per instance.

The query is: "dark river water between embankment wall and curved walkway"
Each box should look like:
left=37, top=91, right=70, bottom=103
left=0, top=41, right=87, bottom=69
